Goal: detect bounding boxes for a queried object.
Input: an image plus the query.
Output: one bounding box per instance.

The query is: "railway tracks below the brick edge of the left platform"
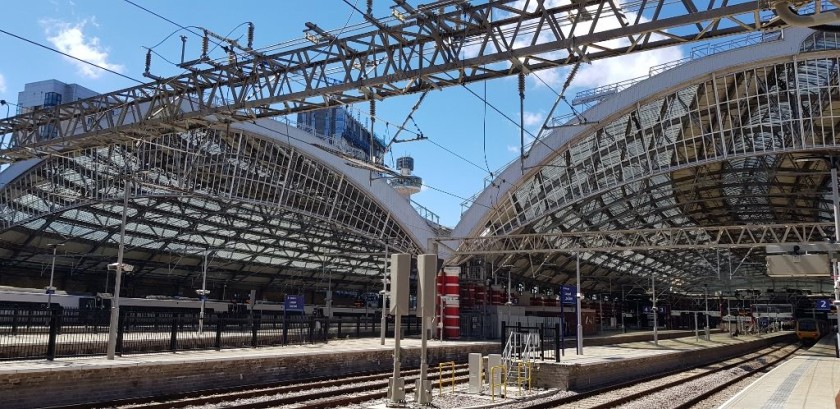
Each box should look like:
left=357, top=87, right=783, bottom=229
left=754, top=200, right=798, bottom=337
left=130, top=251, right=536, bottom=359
left=70, top=364, right=468, bottom=409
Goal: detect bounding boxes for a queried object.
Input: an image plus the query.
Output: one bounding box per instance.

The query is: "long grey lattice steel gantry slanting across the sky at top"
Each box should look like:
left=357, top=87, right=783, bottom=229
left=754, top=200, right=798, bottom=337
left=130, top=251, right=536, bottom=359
left=0, top=0, right=784, bottom=162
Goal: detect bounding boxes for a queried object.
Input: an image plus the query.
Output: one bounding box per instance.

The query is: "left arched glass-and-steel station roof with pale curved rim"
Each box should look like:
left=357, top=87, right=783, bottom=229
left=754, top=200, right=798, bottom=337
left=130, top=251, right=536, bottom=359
left=0, top=120, right=434, bottom=296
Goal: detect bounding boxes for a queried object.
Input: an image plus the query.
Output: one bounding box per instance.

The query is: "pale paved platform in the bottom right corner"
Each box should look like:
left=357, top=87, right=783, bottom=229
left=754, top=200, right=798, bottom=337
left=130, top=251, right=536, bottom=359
left=721, top=334, right=840, bottom=409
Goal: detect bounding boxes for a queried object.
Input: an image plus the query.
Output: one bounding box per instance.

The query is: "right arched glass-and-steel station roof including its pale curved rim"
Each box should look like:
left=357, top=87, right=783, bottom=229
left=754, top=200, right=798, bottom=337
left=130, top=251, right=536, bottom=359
left=453, top=29, right=840, bottom=292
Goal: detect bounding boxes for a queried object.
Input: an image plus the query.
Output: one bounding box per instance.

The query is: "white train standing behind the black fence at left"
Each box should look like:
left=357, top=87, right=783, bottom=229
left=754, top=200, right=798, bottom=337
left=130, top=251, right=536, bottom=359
left=0, top=286, right=381, bottom=316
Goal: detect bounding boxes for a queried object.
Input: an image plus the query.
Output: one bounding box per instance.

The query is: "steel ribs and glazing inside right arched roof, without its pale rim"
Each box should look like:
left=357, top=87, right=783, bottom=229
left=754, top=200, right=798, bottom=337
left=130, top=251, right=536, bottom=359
left=452, top=33, right=840, bottom=291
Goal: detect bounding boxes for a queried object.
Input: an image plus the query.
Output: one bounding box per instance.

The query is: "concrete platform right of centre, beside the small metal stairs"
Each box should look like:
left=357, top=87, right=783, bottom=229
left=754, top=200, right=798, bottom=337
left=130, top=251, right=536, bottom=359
left=535, top=331, right=795, bottom=391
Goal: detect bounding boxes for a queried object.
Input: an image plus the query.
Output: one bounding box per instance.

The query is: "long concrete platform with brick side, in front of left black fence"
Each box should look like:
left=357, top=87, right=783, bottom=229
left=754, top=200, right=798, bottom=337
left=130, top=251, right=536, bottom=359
left=0, top=338, right=492, bottom=409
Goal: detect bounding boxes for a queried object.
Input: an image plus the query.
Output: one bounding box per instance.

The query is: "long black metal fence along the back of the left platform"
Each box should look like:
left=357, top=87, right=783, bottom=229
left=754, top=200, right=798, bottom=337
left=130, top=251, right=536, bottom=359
left=0, top=305, right=420, bottom=360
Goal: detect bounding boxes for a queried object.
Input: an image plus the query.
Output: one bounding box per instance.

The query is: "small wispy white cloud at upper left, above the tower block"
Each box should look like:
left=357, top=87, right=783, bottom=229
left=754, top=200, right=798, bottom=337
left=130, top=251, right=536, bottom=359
left=41, top=20, right=123, bottom=78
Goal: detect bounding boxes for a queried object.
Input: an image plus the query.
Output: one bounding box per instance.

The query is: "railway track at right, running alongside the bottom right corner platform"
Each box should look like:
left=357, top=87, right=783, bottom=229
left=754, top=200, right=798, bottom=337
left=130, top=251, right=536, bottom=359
left=516, top=345, right=799, bottom=409
